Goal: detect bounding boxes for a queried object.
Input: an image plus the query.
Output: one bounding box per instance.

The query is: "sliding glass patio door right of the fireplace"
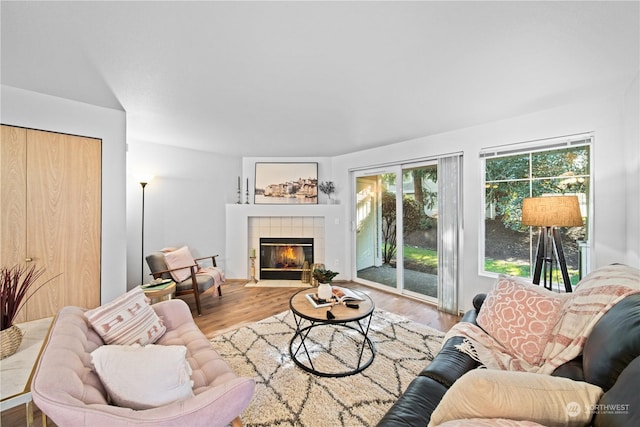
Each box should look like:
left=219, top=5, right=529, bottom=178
left=354, top=161, right=438, bottom=299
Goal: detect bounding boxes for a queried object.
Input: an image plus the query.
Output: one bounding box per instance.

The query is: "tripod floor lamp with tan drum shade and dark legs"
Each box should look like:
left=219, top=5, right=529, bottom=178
left=522, top=196, right=582, bottom=292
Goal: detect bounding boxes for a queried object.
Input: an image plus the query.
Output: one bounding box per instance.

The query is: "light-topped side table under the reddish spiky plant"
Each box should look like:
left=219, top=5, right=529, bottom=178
left=0, top=317, right=53, bottom=426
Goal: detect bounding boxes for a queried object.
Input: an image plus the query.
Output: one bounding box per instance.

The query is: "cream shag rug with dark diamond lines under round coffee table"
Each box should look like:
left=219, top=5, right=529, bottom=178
left=211, top=310, right=444, bottom=427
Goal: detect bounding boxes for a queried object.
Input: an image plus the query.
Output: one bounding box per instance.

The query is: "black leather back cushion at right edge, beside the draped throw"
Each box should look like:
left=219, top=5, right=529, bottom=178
left=583, top=294, right=640, bottom=391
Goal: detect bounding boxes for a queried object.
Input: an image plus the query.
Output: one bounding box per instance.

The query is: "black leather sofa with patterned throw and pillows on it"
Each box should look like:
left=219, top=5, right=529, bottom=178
left=378, top=294, right=640, bottom=427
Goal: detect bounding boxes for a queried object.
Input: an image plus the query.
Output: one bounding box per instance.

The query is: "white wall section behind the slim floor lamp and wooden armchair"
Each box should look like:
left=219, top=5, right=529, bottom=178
left=126, top=141, right=241, bottom=289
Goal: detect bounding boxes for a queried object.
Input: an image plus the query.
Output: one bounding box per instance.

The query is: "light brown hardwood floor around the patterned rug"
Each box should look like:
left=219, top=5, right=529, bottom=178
left=0, top=281, right=460, bottom=427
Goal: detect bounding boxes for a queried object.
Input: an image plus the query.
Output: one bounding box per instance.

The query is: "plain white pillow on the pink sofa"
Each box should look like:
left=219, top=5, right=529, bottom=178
left=91, top=344, right=193, bottom=409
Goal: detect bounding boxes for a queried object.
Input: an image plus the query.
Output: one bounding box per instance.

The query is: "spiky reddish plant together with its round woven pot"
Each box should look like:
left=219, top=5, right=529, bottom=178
left=0, top=264, right=53, bottom=359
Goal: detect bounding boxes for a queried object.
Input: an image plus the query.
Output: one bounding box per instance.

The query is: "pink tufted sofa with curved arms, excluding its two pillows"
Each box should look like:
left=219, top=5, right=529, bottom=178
left=31, top=300, right=255, bottom=427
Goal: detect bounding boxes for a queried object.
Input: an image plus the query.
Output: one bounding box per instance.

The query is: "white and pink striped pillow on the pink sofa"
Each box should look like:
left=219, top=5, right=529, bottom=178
left=85, top=286, right=166, bottom=346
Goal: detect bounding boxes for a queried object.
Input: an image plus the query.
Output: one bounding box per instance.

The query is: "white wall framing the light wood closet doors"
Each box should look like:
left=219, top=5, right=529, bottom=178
left=0, top=85, right=127, bottom=303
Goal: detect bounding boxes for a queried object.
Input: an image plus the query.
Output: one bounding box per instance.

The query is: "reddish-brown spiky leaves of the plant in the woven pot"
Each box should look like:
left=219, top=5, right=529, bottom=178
left=0, top=264, right=57, bottom=331
